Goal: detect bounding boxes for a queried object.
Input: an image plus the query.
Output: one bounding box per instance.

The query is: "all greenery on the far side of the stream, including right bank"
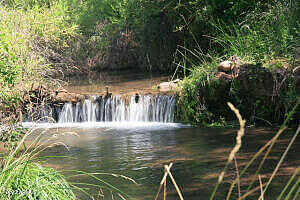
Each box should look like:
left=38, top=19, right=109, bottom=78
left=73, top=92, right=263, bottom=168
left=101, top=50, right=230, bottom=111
left=0, top=0, right=300, bottom=124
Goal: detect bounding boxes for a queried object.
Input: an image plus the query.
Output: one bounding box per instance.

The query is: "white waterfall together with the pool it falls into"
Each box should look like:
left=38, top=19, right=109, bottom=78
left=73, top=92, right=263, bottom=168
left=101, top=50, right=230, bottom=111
left=24, top=99, right=300, bottom=200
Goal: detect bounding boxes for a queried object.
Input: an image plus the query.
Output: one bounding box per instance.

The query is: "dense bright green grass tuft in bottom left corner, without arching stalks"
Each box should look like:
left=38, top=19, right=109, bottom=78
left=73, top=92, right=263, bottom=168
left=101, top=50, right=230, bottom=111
left=0, top=134, right=75, bottom=200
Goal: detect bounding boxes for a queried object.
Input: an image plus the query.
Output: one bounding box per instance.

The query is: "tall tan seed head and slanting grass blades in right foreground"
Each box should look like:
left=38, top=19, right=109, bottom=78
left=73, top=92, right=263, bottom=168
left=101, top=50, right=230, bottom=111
left=210, top=101, right=300, bottom=200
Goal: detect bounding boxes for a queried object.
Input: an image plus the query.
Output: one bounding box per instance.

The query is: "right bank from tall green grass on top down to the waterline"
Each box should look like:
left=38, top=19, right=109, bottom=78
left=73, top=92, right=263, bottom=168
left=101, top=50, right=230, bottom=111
left=176, top=1, right=300, bottom=126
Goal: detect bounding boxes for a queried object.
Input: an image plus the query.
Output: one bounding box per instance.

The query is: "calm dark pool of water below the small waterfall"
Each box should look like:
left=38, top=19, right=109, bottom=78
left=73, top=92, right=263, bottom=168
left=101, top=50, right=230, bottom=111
left=28, top=126, right=300, bottom=200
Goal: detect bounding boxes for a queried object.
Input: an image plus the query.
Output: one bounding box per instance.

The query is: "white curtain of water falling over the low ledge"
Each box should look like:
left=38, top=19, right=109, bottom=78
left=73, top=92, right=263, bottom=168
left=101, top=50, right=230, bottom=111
left=57, top=95, right=176, bottom=123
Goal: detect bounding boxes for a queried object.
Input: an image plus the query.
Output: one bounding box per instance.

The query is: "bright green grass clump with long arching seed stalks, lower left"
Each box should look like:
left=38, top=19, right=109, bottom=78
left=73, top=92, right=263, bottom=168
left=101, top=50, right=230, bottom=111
left=0, top=126, right=137, bottom=200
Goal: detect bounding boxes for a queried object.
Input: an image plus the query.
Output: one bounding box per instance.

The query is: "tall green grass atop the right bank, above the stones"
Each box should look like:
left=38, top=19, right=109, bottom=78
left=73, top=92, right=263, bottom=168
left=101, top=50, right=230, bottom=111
left=215, top=1, right=300, bottom=62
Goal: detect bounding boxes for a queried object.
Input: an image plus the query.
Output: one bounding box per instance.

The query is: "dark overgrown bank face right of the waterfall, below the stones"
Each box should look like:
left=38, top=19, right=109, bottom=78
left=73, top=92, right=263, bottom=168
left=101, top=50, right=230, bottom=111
left=179, top=61, right=297, bottom=125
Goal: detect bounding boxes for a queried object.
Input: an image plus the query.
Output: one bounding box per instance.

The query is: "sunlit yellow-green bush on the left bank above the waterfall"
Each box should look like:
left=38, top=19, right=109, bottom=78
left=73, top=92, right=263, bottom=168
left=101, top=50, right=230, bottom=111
left=0, top=1, right=76, bottom=123
